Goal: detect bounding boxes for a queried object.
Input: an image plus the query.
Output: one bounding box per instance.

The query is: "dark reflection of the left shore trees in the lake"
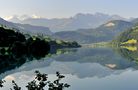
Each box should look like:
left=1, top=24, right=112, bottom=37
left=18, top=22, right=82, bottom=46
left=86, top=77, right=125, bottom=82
left=0, top=48, right=75, bottom=74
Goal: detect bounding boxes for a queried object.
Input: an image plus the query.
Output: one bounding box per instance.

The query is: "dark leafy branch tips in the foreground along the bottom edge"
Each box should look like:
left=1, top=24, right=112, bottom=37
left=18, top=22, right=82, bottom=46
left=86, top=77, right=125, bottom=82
left=0, top=71, right=70, bottom=90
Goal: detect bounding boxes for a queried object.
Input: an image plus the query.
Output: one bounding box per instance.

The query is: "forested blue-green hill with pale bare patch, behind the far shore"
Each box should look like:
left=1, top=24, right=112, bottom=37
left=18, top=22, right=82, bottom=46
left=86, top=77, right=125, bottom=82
left=53, top=20, right=133, bottom=43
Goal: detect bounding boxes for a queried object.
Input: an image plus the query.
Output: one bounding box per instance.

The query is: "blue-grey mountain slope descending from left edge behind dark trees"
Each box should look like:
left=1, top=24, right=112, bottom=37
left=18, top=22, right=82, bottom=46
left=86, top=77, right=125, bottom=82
left=0, top=18, right=52, bottom=35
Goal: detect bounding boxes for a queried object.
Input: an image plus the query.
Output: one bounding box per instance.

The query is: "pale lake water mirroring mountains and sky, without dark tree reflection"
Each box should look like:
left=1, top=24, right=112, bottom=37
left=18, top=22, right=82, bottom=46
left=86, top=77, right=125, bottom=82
left=0, top=48, right=138, bottom=90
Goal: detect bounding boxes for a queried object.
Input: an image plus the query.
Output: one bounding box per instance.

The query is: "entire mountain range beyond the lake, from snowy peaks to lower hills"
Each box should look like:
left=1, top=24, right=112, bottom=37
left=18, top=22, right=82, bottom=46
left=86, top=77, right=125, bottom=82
left=0, top=13, right=138, bottom=44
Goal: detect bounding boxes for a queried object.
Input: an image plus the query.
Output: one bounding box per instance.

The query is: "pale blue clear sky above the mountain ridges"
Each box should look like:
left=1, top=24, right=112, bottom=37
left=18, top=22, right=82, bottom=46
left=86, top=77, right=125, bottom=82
left=0, top=0, right=138, bottom=18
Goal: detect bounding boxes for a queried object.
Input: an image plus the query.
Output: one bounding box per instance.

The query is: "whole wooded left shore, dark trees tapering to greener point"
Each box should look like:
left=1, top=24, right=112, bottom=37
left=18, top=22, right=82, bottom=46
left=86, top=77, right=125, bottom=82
left=0, top=27, right=80, bottom=55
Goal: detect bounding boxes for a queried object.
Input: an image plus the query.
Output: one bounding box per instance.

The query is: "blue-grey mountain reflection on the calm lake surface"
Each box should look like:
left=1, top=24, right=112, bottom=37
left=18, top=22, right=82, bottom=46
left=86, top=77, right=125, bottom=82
left=1, top=48, right=138, bottom=78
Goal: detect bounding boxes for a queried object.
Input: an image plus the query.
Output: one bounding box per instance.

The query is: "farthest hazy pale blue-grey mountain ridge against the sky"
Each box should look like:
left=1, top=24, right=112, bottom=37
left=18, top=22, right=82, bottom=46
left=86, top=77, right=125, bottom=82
left=9, top=13, right=126, bottom=32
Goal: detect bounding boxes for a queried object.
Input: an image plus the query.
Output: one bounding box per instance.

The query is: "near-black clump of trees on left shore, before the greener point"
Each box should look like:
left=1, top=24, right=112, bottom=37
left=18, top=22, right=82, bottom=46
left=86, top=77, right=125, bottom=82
left=0, top=27, right=50, bottom=55
